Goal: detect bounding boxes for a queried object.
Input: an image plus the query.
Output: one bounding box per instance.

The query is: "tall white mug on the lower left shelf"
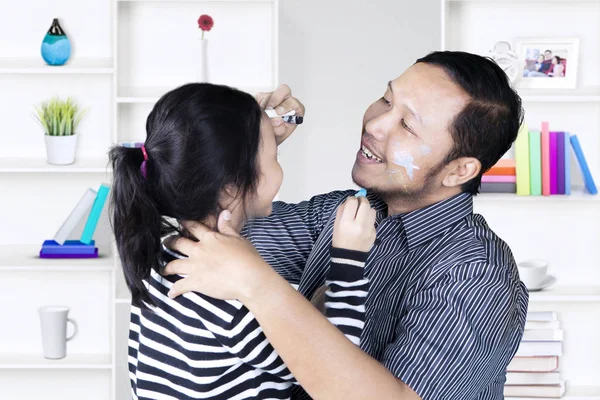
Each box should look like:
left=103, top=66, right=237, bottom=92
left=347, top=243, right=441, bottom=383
left=38, top=306, right=78, bottom=359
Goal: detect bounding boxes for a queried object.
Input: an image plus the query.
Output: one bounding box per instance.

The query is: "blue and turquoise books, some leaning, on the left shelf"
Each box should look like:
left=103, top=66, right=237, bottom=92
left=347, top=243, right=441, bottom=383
left=40, top=184, right=110, bottom=258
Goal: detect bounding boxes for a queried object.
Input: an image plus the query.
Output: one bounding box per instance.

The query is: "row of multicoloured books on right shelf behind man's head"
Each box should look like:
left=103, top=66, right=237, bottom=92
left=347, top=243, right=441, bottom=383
left=480, top=122, right=598, bottom=196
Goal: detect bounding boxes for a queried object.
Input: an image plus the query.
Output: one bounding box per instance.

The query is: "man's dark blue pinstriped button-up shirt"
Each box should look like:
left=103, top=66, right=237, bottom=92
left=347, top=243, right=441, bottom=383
left=244, top=191, right=528, bottom=400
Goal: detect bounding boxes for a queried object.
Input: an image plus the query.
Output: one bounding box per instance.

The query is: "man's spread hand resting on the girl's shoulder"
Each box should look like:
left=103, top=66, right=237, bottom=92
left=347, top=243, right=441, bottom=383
left=163, top=210, right=274, bottom=300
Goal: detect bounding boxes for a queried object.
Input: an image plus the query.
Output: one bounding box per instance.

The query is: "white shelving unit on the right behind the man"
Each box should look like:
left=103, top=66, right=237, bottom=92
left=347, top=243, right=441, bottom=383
left=440, top=0, right=600, bottom=400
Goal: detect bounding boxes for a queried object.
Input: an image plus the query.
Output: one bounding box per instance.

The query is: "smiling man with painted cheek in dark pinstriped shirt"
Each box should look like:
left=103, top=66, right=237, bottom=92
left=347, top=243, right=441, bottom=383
left=165, top=52, right=528, bottom=400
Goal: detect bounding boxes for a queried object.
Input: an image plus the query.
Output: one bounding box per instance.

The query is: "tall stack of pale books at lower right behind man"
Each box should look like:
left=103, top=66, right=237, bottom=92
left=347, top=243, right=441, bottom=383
left=504, top=311, right=565, bottom=400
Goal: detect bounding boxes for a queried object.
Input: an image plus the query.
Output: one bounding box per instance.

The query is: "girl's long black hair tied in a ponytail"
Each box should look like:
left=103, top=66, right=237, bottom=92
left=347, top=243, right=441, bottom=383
left=109, top=83, right=262, bottom=308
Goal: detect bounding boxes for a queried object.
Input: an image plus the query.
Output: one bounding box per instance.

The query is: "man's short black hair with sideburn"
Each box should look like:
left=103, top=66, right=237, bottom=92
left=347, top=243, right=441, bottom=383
left=416, top=51, right=524, bottom=194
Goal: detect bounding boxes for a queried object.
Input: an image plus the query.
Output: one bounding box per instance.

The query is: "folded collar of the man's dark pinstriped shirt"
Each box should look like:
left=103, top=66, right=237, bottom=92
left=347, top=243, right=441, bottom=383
left=399, top=192, right=473, bottom=250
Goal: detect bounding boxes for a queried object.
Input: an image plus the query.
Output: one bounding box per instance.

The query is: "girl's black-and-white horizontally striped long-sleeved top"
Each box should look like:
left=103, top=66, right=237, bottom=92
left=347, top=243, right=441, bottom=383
left=129, top=248, right=368, bottom=400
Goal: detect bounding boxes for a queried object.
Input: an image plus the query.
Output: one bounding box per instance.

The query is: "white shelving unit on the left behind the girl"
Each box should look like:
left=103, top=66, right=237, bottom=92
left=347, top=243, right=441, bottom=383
left=0, top=0, right=279, bottom=400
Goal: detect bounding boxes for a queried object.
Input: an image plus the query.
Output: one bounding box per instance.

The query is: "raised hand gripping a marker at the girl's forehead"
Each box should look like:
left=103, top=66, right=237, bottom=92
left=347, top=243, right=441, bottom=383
left=255, top=85, right=305, bottom=145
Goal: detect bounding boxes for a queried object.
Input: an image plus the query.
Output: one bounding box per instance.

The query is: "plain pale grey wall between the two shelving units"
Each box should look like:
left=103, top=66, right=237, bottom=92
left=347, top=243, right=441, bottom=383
left=279, top=0, right=441, bottom=202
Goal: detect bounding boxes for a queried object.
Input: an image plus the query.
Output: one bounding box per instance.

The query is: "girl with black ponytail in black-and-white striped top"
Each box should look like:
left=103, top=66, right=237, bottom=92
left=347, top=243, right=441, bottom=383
left=110, top=83, right=375, bottom=400
